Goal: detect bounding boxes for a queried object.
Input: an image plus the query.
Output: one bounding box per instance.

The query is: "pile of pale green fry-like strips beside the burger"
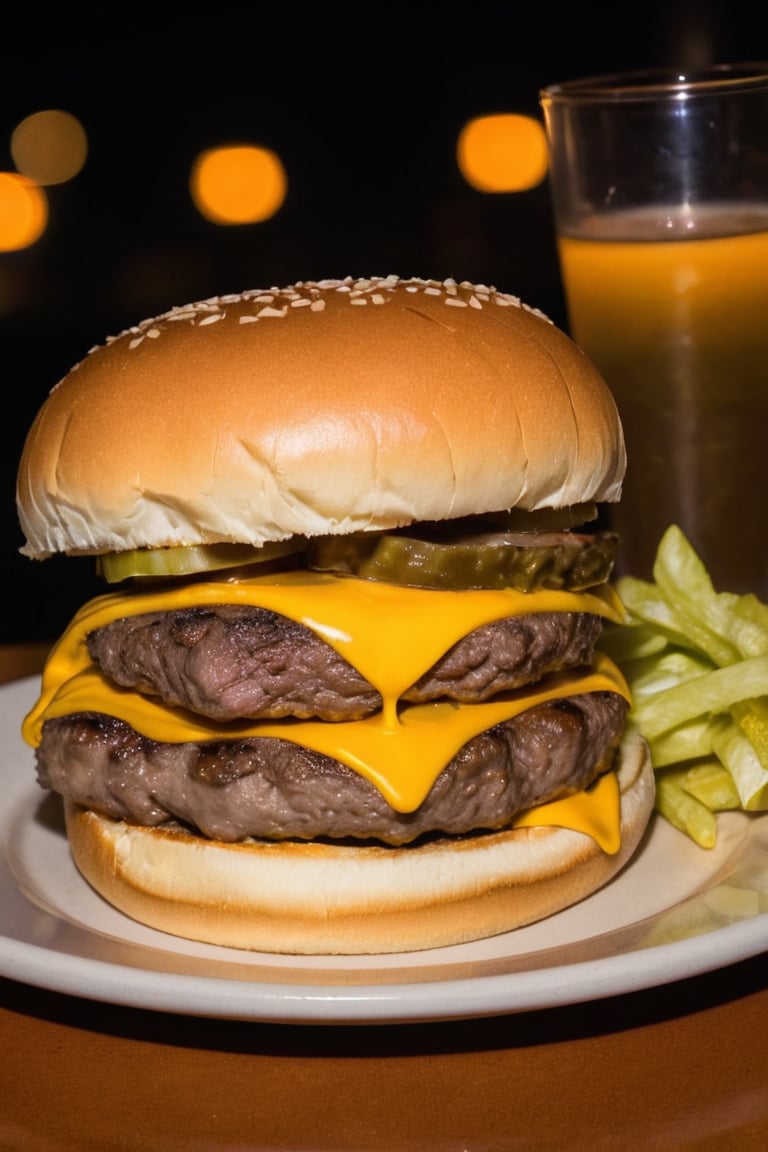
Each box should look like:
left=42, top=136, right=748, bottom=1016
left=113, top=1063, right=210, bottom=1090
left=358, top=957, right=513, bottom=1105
left=601, top=524, right=768, bottom=848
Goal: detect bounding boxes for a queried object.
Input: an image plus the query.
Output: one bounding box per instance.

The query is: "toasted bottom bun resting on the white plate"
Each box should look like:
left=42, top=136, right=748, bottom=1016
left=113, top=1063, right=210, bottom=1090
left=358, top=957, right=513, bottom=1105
left=66, top=733, right=654, bottom=955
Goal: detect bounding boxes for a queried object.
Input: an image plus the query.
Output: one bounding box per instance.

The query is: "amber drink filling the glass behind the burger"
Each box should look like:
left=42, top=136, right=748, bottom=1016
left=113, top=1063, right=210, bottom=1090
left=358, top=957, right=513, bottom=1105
left=558, top=204, right=768, bottom=593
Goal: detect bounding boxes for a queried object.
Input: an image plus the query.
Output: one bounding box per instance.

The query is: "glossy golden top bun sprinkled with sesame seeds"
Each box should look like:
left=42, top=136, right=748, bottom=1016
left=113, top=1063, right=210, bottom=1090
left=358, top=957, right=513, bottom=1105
left=17, top=276, right=625, bottom=559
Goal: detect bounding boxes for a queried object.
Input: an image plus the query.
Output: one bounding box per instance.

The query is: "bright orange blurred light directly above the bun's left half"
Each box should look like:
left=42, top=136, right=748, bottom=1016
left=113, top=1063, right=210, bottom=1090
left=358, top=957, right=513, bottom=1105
left=190, top=144, right=288, bottom=225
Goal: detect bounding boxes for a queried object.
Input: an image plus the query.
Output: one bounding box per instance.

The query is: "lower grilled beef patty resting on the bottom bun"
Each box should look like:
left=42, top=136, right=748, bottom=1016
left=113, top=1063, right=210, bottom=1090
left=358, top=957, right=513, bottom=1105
left=37, top=692, right=628, bottom=844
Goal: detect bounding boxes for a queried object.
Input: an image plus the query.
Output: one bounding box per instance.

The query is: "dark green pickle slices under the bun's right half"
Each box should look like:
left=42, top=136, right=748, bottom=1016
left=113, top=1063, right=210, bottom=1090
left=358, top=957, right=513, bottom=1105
left=309, top=532, right=616, bottom=592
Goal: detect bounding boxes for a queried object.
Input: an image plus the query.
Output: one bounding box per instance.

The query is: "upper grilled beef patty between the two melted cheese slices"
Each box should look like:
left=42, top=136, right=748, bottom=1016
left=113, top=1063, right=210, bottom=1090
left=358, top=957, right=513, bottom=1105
left=88, top=605, right=602, bottom=720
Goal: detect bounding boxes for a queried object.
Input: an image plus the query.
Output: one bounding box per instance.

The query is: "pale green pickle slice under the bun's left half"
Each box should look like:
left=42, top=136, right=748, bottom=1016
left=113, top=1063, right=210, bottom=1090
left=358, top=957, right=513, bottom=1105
left=98, top=537, right=306, bottom=584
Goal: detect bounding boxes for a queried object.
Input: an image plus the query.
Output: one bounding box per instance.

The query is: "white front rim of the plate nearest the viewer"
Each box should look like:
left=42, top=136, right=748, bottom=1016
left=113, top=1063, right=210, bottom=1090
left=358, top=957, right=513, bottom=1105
left=0, top=912, right=768, bottom=1025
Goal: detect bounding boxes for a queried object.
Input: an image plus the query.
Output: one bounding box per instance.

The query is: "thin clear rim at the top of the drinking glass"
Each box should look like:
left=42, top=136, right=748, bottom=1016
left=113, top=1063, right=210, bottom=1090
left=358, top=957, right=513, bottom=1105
left=539, top=60, right=768, bottom=104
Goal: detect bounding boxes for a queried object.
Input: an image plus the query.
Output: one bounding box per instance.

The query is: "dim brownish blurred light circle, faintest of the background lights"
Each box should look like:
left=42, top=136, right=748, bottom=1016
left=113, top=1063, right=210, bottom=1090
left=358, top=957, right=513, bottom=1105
left=10, top=108, right=88, bottom=184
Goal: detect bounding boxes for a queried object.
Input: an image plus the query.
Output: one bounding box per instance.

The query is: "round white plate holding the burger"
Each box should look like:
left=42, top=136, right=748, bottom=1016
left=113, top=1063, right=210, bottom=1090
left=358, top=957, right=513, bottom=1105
left=0, top=677, right=768, bottom=1024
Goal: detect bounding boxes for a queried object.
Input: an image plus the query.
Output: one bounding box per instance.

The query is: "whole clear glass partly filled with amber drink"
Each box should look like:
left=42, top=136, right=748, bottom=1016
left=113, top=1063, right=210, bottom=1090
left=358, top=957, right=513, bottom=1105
left=542, top=66, right=768, bottom=599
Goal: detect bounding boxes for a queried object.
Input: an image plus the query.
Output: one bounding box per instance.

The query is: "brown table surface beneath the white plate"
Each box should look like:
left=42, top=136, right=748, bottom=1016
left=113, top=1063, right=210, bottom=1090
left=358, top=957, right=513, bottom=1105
left=0, top=645, right=768, bottom=1152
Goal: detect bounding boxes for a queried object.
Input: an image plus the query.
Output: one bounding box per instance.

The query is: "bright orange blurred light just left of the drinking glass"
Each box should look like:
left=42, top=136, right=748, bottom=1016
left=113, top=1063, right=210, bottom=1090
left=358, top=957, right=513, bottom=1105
left=456, top=113, right=549, bottom=192
